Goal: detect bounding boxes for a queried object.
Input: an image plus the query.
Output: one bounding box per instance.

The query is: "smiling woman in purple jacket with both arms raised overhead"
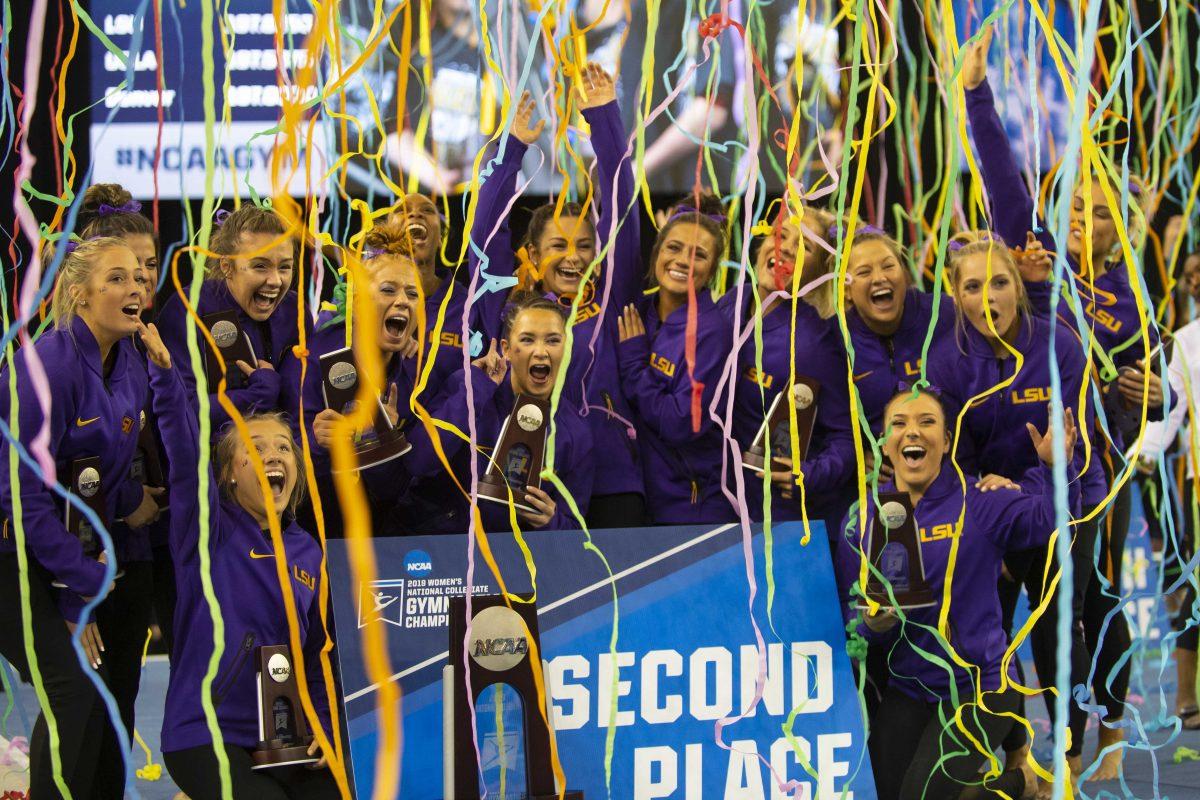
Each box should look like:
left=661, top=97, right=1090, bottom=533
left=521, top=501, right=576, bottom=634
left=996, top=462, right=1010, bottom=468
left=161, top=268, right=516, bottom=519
left=458, top=64, right=646, bottom=528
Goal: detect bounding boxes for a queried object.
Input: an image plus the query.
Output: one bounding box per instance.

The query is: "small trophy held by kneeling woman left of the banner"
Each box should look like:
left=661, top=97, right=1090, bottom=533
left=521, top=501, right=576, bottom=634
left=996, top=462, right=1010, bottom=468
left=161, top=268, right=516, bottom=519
left=251, top=644, right=320, bottom=770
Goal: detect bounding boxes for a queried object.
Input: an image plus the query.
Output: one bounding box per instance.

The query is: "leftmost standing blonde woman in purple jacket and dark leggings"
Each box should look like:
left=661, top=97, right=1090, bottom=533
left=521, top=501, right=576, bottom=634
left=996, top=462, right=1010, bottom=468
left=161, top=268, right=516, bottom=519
left=0, top=237, right=158, bottom=798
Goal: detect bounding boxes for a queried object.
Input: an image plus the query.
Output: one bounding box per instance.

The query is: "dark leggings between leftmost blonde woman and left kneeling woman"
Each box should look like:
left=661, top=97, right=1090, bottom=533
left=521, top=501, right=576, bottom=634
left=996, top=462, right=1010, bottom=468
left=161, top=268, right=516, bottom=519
left=91, top=561, right=154, bottom=800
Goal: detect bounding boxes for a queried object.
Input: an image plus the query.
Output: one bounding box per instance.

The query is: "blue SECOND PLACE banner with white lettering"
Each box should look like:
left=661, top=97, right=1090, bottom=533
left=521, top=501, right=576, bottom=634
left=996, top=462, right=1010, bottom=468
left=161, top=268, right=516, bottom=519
left=329, top=523, right=876, bottom=800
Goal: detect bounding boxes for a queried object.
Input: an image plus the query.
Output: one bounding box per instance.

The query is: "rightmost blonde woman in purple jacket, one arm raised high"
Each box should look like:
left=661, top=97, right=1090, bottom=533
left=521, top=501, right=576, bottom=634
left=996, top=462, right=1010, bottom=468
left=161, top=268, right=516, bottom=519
left=962, top=25, right=1165, bottom=781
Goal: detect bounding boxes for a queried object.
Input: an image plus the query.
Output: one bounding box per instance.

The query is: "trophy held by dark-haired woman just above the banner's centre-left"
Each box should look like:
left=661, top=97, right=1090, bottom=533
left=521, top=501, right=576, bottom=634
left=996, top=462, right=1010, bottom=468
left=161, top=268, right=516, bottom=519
left=479, top=395, right=550, bottom=511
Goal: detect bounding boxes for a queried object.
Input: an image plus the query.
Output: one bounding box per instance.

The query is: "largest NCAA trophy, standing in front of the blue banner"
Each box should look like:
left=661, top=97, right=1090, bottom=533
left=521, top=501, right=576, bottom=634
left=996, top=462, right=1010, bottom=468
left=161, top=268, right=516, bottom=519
left=442, top=595, right=583, bottom=800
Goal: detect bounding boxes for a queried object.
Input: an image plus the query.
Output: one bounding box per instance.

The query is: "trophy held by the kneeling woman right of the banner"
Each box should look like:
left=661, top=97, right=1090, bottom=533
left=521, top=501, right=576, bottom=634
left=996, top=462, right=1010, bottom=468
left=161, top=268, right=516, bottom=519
left=858, top=492, right=936, bottom=609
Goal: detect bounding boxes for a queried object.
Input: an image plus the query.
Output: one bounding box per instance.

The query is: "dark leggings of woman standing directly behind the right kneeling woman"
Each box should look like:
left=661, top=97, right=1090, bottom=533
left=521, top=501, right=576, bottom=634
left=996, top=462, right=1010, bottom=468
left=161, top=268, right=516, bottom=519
left=998, top=519, right=1099, bottom=756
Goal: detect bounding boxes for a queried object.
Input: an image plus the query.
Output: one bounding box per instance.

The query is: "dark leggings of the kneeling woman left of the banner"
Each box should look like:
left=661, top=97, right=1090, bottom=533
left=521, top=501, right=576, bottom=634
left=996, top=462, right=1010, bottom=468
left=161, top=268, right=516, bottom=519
left=162, top=744, right=341, bottom=800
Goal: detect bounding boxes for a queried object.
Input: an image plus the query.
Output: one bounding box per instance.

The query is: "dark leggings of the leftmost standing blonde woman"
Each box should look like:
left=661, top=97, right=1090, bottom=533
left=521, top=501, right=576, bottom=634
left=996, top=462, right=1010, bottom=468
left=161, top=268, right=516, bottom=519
left=0, top=553, right=107, bottom=800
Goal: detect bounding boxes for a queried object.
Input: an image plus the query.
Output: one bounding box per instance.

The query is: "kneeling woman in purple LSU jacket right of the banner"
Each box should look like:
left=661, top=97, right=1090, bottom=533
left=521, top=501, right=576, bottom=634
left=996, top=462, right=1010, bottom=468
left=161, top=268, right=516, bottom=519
left=838, top=390, right=1080, bottom=798
